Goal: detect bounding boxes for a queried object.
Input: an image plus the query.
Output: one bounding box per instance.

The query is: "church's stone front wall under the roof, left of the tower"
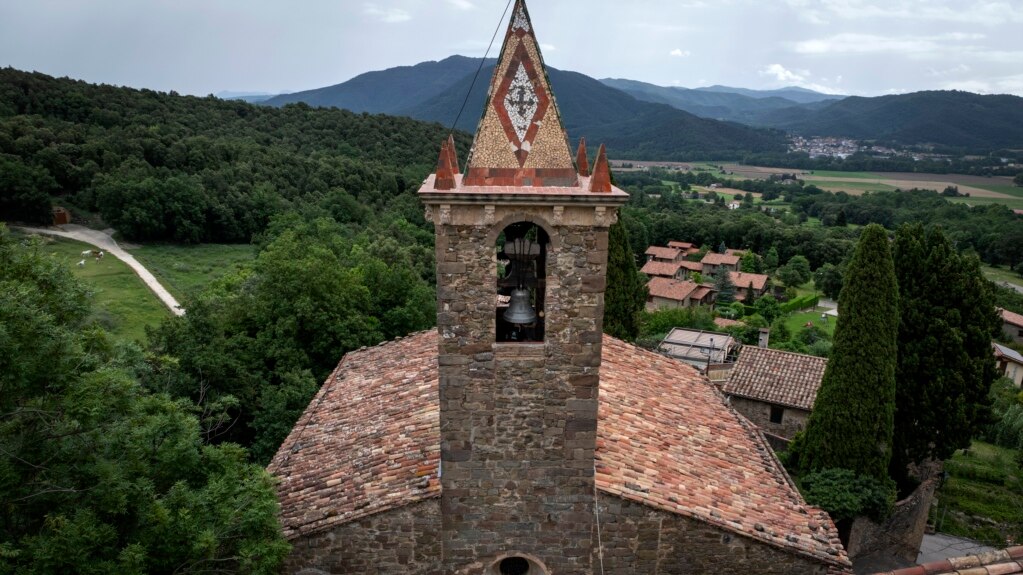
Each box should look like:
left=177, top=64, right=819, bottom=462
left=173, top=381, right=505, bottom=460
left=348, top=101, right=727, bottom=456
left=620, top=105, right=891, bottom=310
left=283, top=499, right=445, bottom=575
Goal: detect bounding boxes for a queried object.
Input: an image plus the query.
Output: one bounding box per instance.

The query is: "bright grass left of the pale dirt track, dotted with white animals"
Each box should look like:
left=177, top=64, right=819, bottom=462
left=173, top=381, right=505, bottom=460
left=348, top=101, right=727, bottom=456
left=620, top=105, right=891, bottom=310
left=14, top=231, right=171, bottom=341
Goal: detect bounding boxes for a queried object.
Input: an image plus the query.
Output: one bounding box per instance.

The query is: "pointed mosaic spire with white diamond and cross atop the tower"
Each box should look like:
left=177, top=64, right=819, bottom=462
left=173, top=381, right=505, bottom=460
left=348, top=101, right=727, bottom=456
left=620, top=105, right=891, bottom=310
left=464, top=0, right=579, bottom=186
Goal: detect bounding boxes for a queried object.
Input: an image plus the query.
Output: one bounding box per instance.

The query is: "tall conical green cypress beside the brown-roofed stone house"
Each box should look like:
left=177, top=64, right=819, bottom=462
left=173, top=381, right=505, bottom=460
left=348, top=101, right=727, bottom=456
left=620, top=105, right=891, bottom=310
left=791, top=224, right=898, bottom=480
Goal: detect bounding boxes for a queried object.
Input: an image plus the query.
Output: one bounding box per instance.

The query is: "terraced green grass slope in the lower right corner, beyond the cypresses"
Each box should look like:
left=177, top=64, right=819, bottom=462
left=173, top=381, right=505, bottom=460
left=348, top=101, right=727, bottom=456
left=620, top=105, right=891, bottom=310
left=931, top=441, right=1023, bottom=548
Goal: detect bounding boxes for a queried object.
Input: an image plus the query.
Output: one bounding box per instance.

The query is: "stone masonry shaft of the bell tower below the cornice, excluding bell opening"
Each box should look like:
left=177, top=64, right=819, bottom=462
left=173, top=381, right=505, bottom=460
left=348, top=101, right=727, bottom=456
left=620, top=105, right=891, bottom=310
left=437, top=207, right=610, bottom=575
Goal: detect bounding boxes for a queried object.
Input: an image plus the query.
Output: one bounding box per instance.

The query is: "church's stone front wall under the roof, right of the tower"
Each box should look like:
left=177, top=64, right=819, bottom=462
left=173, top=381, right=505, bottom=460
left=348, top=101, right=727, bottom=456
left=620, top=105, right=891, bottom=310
left=593, top=493, right=829, bottom=575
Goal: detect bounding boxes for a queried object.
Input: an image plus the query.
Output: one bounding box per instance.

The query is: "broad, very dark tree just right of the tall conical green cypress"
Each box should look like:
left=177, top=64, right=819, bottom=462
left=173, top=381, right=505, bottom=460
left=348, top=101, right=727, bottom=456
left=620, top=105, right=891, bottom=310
left=890, top=224, right=997, bottom=485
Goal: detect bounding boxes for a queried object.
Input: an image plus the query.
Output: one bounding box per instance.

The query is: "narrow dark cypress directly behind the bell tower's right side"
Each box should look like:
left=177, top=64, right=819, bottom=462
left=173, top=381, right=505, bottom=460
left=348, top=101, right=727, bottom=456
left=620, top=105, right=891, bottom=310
left=604, top=218, right=647, bottom=342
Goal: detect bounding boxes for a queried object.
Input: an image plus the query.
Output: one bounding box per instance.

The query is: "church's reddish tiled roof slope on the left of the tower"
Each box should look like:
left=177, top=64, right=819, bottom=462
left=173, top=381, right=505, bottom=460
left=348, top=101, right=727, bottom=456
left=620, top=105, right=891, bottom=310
left=268, top=330, right=441, bottom=537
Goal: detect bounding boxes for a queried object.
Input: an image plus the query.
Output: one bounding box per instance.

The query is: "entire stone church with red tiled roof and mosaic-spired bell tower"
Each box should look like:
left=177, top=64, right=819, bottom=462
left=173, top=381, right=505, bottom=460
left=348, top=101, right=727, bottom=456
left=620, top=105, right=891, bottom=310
left=269, top=0, right=850, bottom=575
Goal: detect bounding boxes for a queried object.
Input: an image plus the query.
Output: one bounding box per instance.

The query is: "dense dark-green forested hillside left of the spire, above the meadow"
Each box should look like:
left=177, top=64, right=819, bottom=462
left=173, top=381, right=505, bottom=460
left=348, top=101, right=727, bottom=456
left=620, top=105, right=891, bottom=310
left=0, top=69, right=469, bottom=242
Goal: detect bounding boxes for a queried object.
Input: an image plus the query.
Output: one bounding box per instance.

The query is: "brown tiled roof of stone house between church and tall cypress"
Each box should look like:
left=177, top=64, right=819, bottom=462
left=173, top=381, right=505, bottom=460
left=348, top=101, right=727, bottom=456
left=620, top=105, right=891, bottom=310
left=724, top=346, right=828, bottom=411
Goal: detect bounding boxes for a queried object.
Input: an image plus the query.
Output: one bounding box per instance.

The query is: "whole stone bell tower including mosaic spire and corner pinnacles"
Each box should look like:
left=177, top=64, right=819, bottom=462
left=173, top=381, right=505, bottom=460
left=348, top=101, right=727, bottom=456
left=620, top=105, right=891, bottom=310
left=419, top=0, right=628, bottom=575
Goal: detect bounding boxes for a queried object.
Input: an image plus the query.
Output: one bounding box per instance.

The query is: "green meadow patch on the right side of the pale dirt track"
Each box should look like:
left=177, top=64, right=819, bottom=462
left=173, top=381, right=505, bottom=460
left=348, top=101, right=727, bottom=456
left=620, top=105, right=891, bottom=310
left=131, top=244, right=256, bottom=302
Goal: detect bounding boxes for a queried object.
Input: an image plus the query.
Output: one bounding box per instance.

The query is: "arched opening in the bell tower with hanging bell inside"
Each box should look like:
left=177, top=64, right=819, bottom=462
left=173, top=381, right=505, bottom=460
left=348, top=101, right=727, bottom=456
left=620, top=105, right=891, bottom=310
left=495, top=222, right=550, bottom=343
